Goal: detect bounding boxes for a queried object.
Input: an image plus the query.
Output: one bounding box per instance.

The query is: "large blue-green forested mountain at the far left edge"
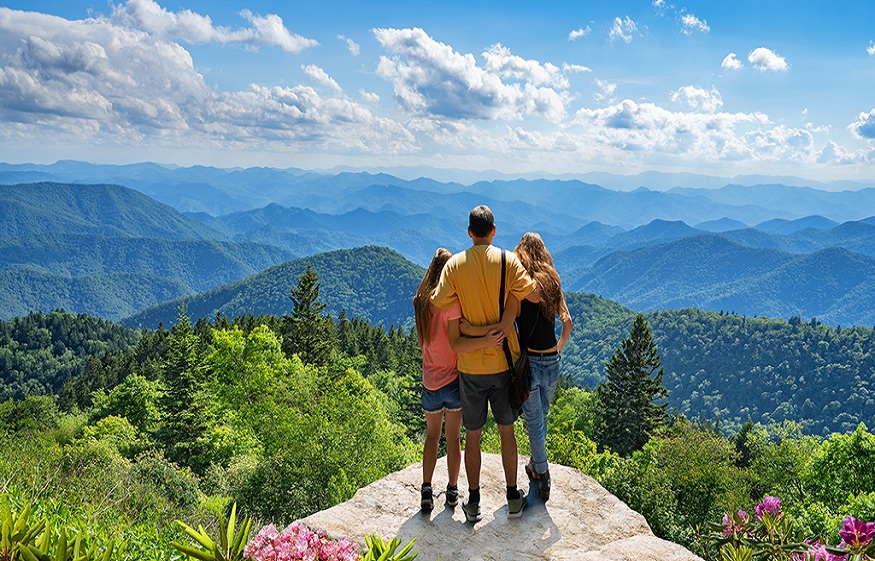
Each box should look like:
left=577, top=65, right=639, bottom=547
left=0, top=183, right=297, bottom=320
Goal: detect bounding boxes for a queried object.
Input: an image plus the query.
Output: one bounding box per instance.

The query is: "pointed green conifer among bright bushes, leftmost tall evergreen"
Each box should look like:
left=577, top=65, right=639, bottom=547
left=156, top=310, right=209, bottom=473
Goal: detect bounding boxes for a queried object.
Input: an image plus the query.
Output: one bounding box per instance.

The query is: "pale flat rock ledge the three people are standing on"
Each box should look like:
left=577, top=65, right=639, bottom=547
left=301, top=454, right=701, bottom=561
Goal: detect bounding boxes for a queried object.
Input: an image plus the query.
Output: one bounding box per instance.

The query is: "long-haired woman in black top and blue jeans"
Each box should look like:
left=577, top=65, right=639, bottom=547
left=514, top=232, right=571, bottom=501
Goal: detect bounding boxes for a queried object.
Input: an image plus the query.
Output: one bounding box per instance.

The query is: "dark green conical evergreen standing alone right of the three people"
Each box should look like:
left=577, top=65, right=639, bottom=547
left=596, top=314, right=668, bottom=456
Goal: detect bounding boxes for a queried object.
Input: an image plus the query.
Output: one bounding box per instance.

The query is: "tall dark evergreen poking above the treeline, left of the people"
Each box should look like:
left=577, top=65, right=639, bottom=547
left=283, top=265, right=337, bottom=366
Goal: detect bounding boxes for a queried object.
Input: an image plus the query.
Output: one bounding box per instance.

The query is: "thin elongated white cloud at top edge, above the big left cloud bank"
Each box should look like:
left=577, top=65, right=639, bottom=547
left=112, top=0, right=319, bottom=53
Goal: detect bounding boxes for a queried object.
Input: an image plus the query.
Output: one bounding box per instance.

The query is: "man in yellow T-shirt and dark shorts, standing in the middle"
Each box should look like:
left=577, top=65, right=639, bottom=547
left=431, top=205, right=536, bottom=522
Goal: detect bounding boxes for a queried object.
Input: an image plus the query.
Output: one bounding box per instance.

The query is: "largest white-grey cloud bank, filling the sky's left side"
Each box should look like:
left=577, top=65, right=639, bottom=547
left=0, top=8, right=417, bottom=152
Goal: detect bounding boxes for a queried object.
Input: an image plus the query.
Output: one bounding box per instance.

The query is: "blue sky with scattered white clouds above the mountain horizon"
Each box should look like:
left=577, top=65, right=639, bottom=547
left=0, top=0, right=875, bottom=179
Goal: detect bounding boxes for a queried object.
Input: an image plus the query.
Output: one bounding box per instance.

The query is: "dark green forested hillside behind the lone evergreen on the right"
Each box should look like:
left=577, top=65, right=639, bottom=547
left=562, top=293, right=875, bottom=436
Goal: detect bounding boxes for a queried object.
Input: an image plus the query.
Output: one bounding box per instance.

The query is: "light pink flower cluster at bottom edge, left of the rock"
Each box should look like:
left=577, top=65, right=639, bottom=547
left=243, top=523, right=359, bottom=561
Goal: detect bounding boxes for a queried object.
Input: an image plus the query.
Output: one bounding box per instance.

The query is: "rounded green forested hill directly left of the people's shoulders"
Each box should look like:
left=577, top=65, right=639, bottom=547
left=122, top=246, right=424, bottom=328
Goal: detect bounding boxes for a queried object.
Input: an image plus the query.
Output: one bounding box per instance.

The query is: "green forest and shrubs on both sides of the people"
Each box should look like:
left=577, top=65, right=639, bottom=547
left=0, top=268, right=875, bottom=560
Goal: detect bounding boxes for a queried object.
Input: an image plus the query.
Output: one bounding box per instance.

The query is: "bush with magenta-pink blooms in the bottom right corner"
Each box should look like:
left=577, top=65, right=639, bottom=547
left=710, top=496, right=875, bottom=561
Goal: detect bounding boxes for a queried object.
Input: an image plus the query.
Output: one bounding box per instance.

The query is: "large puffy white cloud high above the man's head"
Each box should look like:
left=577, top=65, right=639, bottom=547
left=373, top=28, right=570, bottom=121
